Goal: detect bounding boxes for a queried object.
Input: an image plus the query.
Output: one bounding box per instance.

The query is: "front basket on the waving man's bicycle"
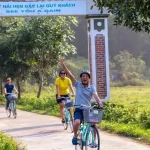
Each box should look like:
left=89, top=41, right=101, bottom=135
left=83, top=109, right=103, bottom=124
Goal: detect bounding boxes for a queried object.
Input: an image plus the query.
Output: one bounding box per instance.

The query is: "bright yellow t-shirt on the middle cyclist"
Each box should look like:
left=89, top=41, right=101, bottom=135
left=55, top=77, right=71, bottom=95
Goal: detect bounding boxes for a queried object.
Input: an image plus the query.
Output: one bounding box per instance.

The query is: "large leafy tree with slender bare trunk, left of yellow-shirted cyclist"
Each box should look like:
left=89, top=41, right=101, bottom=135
left=14, top=17, right=78, bottom=97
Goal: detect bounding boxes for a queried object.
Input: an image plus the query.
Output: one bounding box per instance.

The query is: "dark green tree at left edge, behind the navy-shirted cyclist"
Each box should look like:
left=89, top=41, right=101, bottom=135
left=0, top=17, right=29, bottom=98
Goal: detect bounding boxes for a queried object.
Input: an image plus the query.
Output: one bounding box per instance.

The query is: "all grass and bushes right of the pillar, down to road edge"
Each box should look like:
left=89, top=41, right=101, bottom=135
left=99, top=86, right=150, bottom=144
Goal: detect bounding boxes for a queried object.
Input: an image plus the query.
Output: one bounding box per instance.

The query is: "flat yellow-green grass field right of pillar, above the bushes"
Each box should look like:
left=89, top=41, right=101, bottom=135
left=110, top=86, right=150, bottom=110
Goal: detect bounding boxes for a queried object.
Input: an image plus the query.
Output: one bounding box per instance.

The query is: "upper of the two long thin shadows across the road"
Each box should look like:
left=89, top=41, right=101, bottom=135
left=5, top=124, right=62, bottom=132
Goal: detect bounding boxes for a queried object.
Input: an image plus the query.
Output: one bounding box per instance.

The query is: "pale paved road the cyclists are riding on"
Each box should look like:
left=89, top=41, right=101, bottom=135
left=0, top=106, right=150, bottom=150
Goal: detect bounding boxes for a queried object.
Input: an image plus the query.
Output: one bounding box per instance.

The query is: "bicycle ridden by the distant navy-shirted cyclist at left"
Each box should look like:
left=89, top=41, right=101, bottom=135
left=6, top=93, right=17, bottom=119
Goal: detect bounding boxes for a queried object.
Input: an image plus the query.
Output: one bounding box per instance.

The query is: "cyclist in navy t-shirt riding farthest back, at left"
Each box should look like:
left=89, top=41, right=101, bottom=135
left=4, top=77, right=18, bottom=110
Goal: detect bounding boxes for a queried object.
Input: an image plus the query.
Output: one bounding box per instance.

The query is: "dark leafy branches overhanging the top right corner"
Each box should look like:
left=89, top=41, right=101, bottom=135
left=93, top=0, right=150, bottom=33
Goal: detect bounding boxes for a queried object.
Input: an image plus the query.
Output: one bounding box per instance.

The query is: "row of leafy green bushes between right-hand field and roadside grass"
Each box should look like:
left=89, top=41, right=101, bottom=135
left=103, top=102, right=150, bottom=129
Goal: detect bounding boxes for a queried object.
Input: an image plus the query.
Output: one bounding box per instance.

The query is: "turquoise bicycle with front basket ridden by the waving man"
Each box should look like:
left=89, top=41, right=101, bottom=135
left=74, top=105, right=103, bottom=150
